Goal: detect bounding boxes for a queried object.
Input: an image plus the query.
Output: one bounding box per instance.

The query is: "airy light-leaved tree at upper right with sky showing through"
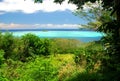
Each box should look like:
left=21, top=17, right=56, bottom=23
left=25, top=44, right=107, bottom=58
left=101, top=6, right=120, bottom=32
left=74, top=1, right=113, bottom=30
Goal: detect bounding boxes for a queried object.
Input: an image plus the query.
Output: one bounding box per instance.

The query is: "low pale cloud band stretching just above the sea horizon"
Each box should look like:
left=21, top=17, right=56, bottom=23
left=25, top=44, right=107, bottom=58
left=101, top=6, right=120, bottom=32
left=0, top=23, right=81, bottom=29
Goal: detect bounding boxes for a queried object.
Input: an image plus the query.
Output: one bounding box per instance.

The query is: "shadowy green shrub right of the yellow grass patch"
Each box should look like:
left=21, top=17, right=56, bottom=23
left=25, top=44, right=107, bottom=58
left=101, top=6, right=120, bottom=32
left=74, top=42, right=104, bottom=71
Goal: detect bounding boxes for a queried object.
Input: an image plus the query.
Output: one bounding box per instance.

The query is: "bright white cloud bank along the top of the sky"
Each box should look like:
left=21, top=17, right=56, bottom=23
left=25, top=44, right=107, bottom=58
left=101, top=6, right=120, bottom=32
left=0, top=0, right=76, bottom=13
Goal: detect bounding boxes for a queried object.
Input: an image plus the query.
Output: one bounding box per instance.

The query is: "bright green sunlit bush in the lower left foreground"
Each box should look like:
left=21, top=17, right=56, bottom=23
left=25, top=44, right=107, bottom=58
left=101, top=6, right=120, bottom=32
left=0, top=56, right=58, bottom=81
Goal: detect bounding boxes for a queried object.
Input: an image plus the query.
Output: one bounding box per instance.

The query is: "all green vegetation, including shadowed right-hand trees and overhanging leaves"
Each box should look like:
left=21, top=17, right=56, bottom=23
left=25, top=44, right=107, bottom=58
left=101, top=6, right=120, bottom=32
left=0, top=0, right=120, bottom=81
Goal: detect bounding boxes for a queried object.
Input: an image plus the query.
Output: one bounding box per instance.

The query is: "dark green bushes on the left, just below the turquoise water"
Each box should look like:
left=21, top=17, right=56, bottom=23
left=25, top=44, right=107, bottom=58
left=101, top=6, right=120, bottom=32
left=0, top=32, right=52, bottom=62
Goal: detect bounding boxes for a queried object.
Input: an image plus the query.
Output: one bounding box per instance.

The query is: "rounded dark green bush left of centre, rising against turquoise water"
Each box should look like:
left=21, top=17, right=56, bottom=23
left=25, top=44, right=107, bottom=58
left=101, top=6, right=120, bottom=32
left=21, top=34, right=51, bottom=60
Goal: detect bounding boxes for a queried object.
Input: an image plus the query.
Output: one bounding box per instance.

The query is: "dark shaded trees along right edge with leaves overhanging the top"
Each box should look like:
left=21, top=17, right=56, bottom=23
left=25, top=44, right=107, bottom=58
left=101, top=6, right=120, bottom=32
left=34, top=0, right=120, bottom=81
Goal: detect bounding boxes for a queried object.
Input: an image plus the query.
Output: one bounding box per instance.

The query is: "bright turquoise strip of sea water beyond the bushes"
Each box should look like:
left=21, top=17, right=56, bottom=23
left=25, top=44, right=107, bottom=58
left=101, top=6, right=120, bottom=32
left=2, top=30, right=103, bottom=42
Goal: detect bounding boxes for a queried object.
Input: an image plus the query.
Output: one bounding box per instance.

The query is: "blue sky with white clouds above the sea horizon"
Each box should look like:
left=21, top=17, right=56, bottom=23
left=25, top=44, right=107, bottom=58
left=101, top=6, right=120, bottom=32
left=0, top=0, right=86, bottom=29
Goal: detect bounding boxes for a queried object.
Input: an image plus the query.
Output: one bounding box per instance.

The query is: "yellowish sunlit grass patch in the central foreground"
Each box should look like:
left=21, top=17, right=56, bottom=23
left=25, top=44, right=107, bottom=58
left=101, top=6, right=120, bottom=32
left=51, top=54, right=84, bottom=81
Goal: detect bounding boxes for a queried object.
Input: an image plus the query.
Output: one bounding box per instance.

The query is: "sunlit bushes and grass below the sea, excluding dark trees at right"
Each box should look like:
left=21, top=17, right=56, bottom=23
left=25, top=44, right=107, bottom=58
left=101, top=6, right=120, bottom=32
left=0, top=32, right=103, bottom=81
